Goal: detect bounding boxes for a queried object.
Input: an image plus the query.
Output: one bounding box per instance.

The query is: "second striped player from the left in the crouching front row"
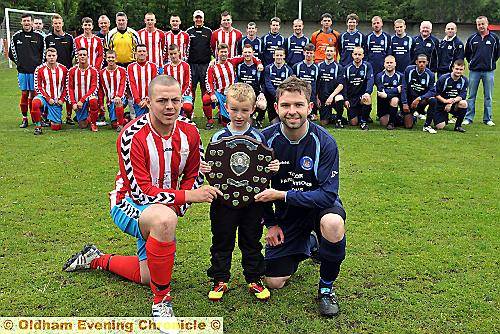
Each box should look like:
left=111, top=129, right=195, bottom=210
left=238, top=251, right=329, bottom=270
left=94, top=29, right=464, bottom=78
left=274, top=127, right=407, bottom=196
left=67, top=48, right=99, bottom=132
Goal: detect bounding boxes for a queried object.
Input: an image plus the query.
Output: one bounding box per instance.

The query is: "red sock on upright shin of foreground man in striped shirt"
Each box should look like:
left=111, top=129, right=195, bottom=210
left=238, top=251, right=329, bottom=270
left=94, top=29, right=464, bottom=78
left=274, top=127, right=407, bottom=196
left=146, top=235, right=175, bottom=304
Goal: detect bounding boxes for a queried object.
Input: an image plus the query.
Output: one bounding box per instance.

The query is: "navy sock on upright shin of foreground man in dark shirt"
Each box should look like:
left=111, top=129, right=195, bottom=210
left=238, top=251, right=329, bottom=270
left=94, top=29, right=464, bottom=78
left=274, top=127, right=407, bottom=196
left=319, top=235, right=346, bottom=282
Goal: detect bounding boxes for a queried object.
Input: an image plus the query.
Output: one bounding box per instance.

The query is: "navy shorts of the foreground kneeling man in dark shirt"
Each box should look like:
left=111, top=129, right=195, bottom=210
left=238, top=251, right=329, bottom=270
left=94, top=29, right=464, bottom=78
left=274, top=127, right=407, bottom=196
left=266, top=205, right=346, bottom=277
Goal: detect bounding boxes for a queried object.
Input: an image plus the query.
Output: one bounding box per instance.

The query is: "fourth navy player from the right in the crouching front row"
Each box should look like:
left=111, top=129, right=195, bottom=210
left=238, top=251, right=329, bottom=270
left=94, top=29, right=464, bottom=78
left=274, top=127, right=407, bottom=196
left=344, top=46, right=374, bottom=130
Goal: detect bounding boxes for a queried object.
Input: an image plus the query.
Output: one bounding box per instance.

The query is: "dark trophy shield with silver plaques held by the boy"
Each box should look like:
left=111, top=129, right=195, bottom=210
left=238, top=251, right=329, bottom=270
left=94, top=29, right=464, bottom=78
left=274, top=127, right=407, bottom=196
left=205, top=136, right=274, bottom=208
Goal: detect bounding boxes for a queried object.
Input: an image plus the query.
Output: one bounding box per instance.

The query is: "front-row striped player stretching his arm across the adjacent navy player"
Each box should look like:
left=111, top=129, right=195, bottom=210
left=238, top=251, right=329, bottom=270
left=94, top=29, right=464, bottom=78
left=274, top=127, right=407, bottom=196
left=203, top=43, right=264, bottom=130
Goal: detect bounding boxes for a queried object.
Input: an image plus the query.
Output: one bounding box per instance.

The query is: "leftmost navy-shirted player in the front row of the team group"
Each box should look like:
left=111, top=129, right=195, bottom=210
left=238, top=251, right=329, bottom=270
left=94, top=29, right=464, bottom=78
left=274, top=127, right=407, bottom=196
left=236, top=44, right=267, bottom=128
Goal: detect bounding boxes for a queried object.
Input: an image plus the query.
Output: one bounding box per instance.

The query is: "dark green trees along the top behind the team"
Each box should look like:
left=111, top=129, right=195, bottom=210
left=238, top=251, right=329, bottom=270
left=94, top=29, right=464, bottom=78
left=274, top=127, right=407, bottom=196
left=0, top=0, right=500, bottom=30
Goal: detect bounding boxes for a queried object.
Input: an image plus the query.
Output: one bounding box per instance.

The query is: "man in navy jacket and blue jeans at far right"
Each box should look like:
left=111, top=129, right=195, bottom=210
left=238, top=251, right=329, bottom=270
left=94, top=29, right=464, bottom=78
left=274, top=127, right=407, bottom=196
left=463, top=16, right=500, bottom=126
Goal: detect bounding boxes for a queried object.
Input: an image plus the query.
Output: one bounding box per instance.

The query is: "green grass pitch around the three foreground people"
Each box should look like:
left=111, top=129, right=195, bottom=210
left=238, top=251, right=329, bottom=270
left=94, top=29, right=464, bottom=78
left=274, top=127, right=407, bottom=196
left=0, top=69, right=500, bottom=333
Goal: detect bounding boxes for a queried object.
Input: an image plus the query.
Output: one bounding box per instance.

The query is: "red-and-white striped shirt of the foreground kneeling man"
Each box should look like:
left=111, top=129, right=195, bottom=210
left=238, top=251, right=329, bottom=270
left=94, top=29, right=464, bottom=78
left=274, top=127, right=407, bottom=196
left=110, top=114, right=203, bottom=215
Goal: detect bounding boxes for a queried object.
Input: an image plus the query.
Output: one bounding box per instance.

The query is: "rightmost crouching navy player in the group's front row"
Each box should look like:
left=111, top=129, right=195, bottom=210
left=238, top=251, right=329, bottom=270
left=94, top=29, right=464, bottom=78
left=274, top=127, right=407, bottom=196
left=434, top=59, right=469, bottom=132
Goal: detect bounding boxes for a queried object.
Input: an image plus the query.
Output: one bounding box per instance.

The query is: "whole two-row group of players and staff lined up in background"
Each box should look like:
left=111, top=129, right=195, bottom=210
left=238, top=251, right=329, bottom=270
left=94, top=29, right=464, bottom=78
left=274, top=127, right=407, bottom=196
left=9, top=10, right=500, bottom=134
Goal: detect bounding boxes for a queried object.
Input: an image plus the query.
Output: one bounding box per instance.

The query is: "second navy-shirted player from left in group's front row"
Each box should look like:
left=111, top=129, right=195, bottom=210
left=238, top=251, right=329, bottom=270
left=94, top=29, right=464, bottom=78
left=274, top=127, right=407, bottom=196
left=264, top=48, right=293, bottom=123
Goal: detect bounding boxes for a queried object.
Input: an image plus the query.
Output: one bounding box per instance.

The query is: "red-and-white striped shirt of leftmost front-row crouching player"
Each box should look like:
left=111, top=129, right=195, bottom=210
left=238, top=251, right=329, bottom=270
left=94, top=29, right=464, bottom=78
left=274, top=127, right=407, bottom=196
left=35, top=63, right=68, bottom=102
